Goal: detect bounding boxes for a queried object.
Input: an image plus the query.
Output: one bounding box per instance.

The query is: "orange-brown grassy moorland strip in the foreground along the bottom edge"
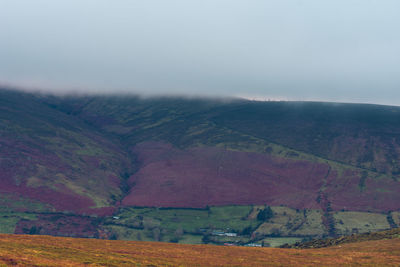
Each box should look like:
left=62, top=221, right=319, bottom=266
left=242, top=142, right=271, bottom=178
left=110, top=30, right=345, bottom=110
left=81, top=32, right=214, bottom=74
left=0, top=234, right=400, bottom=266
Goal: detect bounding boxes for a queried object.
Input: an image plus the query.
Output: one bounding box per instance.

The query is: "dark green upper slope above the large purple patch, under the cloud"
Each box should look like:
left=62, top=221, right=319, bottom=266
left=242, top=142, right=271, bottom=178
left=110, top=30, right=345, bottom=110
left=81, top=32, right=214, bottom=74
left=47, top=94, right=400, bottom=175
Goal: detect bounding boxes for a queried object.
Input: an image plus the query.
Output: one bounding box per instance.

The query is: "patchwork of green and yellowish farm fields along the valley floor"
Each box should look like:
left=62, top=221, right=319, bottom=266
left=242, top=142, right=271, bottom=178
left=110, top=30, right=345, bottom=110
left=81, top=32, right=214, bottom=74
left=0, top=206, right=398, bottom=247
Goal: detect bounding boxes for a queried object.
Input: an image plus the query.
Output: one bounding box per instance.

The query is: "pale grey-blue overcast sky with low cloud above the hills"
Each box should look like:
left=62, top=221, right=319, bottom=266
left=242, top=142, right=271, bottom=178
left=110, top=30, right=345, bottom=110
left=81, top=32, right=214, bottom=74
left=0, top=0, right=400, bottom=105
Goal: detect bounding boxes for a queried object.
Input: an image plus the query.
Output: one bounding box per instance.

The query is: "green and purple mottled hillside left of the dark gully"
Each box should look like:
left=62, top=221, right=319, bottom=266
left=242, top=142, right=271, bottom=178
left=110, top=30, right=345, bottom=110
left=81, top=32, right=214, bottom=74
left=0, top=91, right=131, bottom=214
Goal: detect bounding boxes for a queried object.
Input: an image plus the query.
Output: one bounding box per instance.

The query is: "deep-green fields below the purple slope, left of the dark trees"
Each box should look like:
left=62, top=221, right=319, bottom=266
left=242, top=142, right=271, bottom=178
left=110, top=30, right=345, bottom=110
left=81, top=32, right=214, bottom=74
left=105, top=206, right=262, bottom=244
